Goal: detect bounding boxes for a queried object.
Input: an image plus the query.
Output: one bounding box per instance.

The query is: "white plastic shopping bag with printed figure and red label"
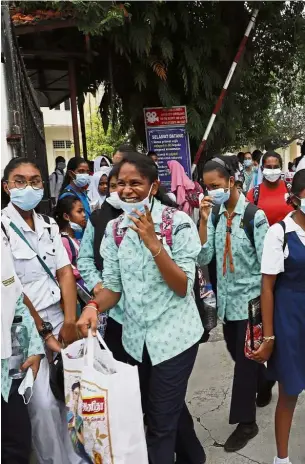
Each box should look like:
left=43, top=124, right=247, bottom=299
left=62, top=331, right=148, bottom=464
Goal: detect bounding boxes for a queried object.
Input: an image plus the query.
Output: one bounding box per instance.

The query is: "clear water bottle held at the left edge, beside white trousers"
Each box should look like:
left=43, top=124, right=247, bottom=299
left=8, top=316, right=29, bottom=379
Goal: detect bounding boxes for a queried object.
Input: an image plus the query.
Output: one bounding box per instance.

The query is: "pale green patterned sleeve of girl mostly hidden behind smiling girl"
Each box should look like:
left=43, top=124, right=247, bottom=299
left=77, top=220, right=102, bottom=290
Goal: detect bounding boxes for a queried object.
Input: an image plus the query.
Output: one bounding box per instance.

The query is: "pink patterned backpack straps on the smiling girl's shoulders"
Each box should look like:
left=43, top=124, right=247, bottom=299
left=112, top=206, right=178, bottom=247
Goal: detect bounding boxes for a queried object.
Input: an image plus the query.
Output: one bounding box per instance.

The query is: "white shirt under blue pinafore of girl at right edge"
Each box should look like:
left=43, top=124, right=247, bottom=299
left=261, top=211, right=305, bottom=275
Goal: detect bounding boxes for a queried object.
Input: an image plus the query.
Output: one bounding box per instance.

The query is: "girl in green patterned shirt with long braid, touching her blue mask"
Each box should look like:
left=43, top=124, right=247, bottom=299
left=198, top=156, right=273, bottom=452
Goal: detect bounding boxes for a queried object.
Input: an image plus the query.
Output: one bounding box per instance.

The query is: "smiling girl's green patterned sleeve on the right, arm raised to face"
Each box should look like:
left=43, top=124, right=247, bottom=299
left=171, top=212, right=201, bottom=293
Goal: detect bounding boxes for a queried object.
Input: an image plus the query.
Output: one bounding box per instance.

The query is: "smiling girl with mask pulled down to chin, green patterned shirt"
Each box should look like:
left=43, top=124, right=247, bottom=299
left=78, top=153, right=206, bottom=464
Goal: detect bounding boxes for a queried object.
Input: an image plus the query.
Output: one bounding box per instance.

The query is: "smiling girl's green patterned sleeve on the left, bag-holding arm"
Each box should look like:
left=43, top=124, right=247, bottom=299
left=100, top=221, right=122, bottom=293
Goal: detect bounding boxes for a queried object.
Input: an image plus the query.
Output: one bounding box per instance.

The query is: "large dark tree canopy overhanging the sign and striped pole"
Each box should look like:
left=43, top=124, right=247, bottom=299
left=14, top=1, right=305, bottom=158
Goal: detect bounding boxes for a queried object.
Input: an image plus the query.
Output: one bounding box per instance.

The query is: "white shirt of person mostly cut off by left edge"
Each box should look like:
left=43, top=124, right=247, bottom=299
left=1, top=230, right=22, bottom=359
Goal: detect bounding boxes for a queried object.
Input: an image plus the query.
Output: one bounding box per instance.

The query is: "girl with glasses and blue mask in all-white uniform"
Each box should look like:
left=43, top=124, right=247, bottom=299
left=2, top=158, right=81, bottom=464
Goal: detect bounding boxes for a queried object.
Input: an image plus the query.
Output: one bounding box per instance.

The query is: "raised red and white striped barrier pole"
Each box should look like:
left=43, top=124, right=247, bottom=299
left=192, top=10, right=258, bottom=173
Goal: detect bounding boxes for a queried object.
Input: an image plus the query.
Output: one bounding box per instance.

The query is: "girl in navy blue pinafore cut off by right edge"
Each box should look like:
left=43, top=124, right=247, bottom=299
left=253, top=169, right=305, bottom=464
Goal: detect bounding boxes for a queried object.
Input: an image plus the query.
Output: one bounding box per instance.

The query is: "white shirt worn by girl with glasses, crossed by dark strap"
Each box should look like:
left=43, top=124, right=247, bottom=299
left=2, top=203, right=71, bottom=311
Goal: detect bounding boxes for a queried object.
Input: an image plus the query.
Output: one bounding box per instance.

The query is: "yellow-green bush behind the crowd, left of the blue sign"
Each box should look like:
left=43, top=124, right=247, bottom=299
left=86, top=114, right=126, bottom=160
